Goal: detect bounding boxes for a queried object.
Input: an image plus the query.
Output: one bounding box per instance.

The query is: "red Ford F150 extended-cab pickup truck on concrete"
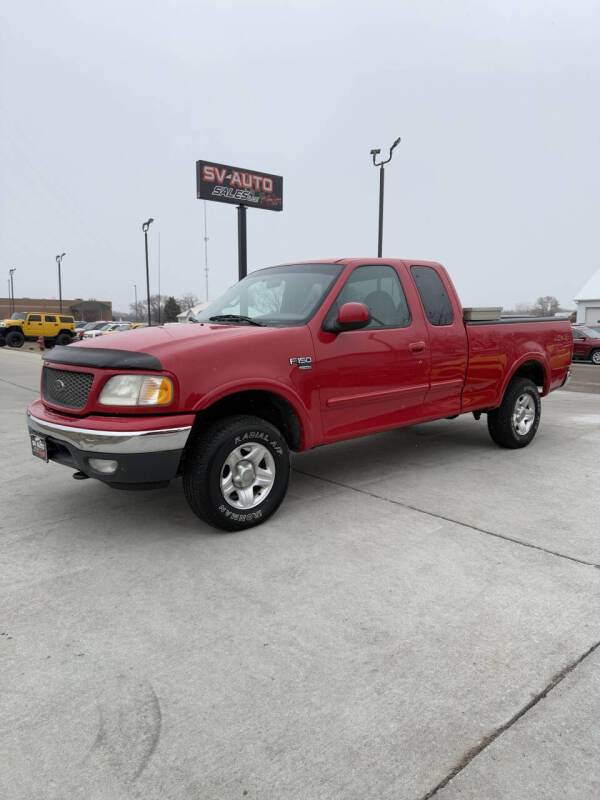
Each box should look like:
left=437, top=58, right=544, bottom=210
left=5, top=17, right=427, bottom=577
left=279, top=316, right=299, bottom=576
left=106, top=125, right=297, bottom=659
left=28, top=258, right=573, bottom=530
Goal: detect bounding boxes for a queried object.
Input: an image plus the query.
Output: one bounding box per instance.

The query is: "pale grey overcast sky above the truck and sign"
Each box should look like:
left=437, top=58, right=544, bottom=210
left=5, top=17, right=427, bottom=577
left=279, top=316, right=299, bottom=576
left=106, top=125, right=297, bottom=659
left=0, top=0, right=600, bottom=310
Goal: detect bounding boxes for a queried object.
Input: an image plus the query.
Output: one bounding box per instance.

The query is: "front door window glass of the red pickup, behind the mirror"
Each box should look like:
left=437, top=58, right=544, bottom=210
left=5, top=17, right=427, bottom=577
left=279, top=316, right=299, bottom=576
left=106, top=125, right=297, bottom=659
left=330, top=265, right=411, bottom=329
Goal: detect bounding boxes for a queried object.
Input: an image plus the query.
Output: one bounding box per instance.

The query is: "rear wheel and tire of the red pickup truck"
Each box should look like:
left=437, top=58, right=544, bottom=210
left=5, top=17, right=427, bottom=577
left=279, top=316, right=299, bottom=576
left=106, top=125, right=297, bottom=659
left=488, top=378, right=542, bottom=450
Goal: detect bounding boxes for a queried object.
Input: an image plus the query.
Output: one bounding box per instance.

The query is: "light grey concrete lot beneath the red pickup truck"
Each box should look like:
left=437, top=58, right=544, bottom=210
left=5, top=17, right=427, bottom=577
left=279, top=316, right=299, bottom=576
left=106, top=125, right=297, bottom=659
left=0, top=350, right=600, bottom=800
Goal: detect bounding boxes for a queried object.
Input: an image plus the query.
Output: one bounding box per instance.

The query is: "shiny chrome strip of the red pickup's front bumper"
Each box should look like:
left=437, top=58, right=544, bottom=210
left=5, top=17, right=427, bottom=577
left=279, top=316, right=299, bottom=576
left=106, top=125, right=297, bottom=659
left=27, top=411, right=192, bottom=455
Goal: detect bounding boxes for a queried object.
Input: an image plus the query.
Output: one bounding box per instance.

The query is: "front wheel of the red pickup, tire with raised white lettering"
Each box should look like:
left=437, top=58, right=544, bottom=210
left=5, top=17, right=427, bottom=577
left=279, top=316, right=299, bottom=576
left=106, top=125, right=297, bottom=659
left=183, top=416, right=290, bottom=531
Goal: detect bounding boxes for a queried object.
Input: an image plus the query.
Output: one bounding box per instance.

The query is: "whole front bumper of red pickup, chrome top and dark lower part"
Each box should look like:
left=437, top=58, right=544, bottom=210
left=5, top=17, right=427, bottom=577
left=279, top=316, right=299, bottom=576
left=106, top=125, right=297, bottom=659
left=27, top=404, right=193, bottom=489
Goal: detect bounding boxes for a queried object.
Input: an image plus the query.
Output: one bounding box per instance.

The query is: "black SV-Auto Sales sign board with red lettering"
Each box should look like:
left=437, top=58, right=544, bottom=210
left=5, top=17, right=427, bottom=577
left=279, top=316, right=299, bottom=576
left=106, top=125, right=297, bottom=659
left=196, top=161, right=283, bottom=211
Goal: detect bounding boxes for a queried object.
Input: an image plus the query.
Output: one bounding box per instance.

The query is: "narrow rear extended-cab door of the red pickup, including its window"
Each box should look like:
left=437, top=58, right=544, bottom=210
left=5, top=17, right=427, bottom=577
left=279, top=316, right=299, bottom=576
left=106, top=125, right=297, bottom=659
left=410, top=264, right=468, bottom=418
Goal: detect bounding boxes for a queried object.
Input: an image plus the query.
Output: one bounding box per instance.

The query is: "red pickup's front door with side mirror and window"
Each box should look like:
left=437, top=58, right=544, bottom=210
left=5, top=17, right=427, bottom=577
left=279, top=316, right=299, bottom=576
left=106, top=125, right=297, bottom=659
left=315, top=263, right=429, bottom=441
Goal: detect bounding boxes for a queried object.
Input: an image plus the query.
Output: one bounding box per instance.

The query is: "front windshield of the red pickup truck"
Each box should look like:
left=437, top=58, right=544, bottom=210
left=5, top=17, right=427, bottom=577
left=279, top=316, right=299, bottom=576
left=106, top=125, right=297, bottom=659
left=196, top=264, right=344, bottom=327
